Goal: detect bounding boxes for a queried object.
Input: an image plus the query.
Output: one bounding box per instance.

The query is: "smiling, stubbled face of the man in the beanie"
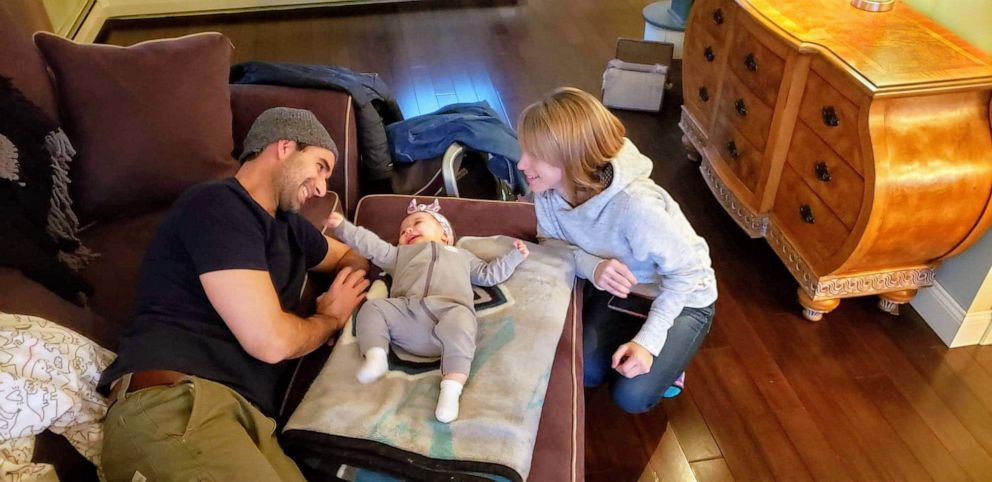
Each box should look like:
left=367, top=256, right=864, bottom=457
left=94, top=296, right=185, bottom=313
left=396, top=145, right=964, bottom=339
left=275, top=146, right=335, bottom=213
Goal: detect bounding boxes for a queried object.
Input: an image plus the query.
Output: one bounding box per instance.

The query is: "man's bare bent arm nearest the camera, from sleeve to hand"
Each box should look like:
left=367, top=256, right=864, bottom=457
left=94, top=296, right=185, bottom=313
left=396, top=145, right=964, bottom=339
left=200, top=266, right=369, bottom=363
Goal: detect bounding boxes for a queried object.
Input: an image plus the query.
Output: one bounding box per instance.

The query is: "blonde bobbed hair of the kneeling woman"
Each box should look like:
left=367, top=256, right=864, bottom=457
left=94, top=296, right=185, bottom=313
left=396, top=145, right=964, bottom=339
left=517, top=87, right=626, bottom=204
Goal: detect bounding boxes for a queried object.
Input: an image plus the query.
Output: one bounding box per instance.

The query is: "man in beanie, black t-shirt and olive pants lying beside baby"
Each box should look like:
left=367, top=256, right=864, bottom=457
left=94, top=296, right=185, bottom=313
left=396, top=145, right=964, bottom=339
left=100, top=107, right=368, bottom=481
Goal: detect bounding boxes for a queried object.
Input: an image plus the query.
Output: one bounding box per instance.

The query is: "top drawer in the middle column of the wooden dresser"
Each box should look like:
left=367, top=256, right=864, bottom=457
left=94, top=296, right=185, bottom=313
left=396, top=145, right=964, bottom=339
left=728, top=15, right=785, bottom=108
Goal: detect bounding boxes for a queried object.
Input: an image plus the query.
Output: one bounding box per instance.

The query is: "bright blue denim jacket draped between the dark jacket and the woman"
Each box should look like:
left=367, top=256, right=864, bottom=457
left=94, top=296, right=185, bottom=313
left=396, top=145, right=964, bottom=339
left=386, top=101, right=528, bottom=194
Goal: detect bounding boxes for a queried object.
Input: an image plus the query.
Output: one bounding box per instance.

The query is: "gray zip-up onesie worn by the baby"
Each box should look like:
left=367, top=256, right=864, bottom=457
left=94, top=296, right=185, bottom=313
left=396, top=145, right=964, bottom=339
left=334, top=221, right=524, bottom=374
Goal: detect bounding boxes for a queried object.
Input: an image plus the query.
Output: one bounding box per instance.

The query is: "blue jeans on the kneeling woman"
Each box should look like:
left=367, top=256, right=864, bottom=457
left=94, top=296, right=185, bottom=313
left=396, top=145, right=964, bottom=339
left=582, top=284, right=716, bottom=413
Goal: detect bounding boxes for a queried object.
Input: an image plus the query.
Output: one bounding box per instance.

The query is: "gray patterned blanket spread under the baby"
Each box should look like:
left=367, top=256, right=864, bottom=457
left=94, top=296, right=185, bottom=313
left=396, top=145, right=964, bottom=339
left=284, top=236, right=574, bottom=480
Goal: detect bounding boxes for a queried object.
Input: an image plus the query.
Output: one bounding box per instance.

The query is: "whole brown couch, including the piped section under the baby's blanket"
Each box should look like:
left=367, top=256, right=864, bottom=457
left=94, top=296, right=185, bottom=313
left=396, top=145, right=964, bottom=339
left=0, top=0, right=584, bottom=481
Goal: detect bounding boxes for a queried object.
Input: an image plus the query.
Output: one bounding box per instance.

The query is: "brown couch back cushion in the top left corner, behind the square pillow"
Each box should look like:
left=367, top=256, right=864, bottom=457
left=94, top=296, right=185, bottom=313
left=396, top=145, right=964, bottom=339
left=0, top=0, right=59, bottom=122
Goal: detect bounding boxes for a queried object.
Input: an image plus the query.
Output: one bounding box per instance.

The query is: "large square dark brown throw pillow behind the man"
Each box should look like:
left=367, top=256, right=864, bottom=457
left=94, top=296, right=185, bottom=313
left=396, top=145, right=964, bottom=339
left=35, top=33, right=238, bottom=219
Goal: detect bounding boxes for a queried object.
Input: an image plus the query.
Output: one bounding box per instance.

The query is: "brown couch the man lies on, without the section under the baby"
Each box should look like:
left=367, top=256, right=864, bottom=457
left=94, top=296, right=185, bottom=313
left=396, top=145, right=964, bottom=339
left=0, top=0, right=358, bottom=481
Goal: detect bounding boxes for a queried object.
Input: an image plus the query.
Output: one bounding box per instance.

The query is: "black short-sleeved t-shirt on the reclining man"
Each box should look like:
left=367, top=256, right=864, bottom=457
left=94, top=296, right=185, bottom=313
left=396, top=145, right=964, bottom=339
left=99, top=178, right=327, bottom=416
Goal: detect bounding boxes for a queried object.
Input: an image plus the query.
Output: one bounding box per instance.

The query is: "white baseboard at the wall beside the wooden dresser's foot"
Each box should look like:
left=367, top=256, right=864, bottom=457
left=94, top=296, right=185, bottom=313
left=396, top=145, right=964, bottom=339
left=909, top=282, right=992, bottom=348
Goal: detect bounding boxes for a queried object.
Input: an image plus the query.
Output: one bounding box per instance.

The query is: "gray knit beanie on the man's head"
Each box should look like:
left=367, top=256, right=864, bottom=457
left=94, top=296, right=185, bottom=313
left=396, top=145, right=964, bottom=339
left=238, top=107, right=338, bottom=162
